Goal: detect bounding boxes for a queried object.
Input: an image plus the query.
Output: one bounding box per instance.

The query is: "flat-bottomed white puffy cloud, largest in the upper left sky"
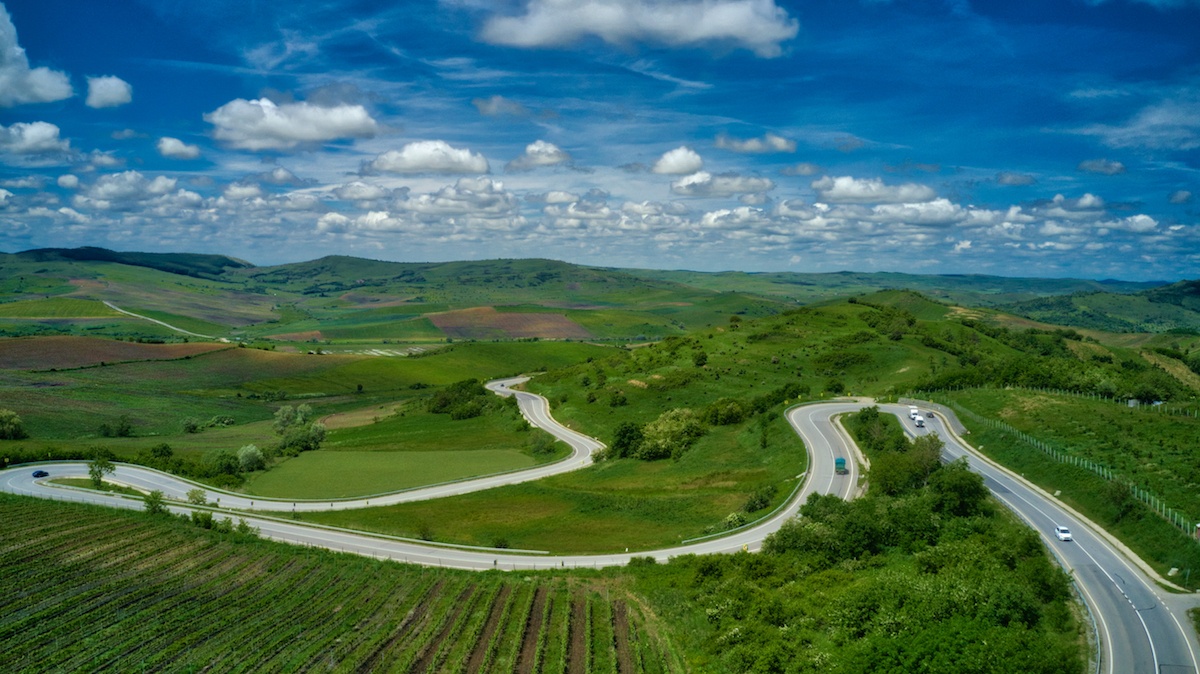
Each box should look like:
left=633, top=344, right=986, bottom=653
left=204, top=98, right=378, bottom=150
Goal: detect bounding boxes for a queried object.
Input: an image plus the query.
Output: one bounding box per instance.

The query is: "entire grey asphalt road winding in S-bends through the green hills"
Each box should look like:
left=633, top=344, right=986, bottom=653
left=0, top=386, right=1200, bottom=674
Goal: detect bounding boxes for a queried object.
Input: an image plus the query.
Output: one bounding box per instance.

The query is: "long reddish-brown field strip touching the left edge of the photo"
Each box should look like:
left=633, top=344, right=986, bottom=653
left=0, top=337, right=229, bottom=369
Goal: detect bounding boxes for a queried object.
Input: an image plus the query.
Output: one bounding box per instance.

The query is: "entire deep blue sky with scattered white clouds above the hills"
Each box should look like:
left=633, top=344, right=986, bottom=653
left=0, top=0, right=1200, bottom=281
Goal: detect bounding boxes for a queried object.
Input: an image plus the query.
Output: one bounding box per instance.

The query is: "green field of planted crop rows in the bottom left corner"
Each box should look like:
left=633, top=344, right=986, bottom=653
left=0, top=495, right=674, bottom=674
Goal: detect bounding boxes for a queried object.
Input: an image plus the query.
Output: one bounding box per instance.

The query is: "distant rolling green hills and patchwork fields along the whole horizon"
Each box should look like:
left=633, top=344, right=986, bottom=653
left=0, top=247, right=1200, bottom=345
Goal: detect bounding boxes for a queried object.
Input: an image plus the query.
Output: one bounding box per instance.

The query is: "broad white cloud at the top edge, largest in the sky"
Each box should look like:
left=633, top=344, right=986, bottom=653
left=482, top=0, right=799, bottom=58
